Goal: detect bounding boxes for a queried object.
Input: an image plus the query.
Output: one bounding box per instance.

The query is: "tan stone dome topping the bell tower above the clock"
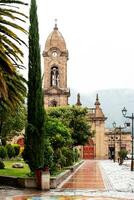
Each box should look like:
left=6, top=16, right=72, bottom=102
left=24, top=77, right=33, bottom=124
left=45, top=24, right=67, bottom=51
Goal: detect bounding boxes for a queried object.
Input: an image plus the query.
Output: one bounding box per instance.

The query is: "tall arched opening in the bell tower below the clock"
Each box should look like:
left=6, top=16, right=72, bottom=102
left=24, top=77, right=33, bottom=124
left=50, top=66, right=59, bottom=87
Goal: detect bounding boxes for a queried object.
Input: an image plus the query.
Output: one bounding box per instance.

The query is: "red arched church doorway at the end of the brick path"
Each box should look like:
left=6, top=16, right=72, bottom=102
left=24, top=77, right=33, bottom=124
left=83, top=139, right=95, bottom=159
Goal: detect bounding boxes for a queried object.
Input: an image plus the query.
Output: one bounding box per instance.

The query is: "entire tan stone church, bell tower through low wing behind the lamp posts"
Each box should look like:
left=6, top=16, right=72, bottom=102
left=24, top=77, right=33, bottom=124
left=12, top=23, right=131, bottom=159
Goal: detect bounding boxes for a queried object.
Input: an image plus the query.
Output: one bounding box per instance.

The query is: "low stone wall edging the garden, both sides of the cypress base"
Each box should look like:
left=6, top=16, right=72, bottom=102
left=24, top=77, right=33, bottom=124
left=0, top=161, right=83, bottom=189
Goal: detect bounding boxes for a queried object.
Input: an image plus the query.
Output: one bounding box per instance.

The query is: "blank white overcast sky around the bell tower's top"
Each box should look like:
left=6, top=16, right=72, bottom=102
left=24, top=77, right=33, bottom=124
left=22, top=0, right=134, bottom=93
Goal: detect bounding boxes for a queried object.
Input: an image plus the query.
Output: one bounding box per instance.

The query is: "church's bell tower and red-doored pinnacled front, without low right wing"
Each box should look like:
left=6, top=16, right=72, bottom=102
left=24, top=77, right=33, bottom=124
left=43, top=23, right=111, bottom=159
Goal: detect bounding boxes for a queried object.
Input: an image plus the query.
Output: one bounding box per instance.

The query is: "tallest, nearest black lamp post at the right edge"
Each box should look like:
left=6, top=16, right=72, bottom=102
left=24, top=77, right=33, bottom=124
left=122, top=107, right=134, bottom=171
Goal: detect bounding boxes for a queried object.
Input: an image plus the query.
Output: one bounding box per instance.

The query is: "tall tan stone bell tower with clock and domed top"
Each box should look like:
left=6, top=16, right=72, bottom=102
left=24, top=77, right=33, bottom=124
left=43, top=22, right=70, bottom=108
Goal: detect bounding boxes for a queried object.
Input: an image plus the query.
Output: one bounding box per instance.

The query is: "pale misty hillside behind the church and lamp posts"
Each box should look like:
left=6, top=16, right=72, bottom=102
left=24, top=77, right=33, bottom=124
left=69, top=89, right=134, bottom=127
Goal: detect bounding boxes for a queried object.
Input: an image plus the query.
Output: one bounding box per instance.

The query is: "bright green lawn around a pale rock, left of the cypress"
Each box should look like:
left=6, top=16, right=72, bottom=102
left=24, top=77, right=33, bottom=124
left=0, top=160, right=30, bottom=178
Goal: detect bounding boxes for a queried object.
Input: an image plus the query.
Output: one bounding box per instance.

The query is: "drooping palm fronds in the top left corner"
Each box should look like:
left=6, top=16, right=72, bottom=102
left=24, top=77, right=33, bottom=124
left=0, top=0, right=27, bottom=105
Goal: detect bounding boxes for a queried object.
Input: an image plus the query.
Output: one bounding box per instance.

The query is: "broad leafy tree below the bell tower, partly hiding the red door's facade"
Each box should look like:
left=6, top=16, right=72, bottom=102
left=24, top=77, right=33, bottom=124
left=48, top=106, right=93, bottom=146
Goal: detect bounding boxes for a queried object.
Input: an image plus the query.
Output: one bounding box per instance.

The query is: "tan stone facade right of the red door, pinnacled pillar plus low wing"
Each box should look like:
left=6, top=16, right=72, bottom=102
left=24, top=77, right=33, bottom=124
left=87, top=95, right=132, bottom=159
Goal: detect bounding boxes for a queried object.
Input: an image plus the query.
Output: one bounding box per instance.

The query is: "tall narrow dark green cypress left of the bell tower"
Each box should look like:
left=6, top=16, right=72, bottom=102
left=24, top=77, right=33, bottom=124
left=23, top=0, right=45, bottom=171
